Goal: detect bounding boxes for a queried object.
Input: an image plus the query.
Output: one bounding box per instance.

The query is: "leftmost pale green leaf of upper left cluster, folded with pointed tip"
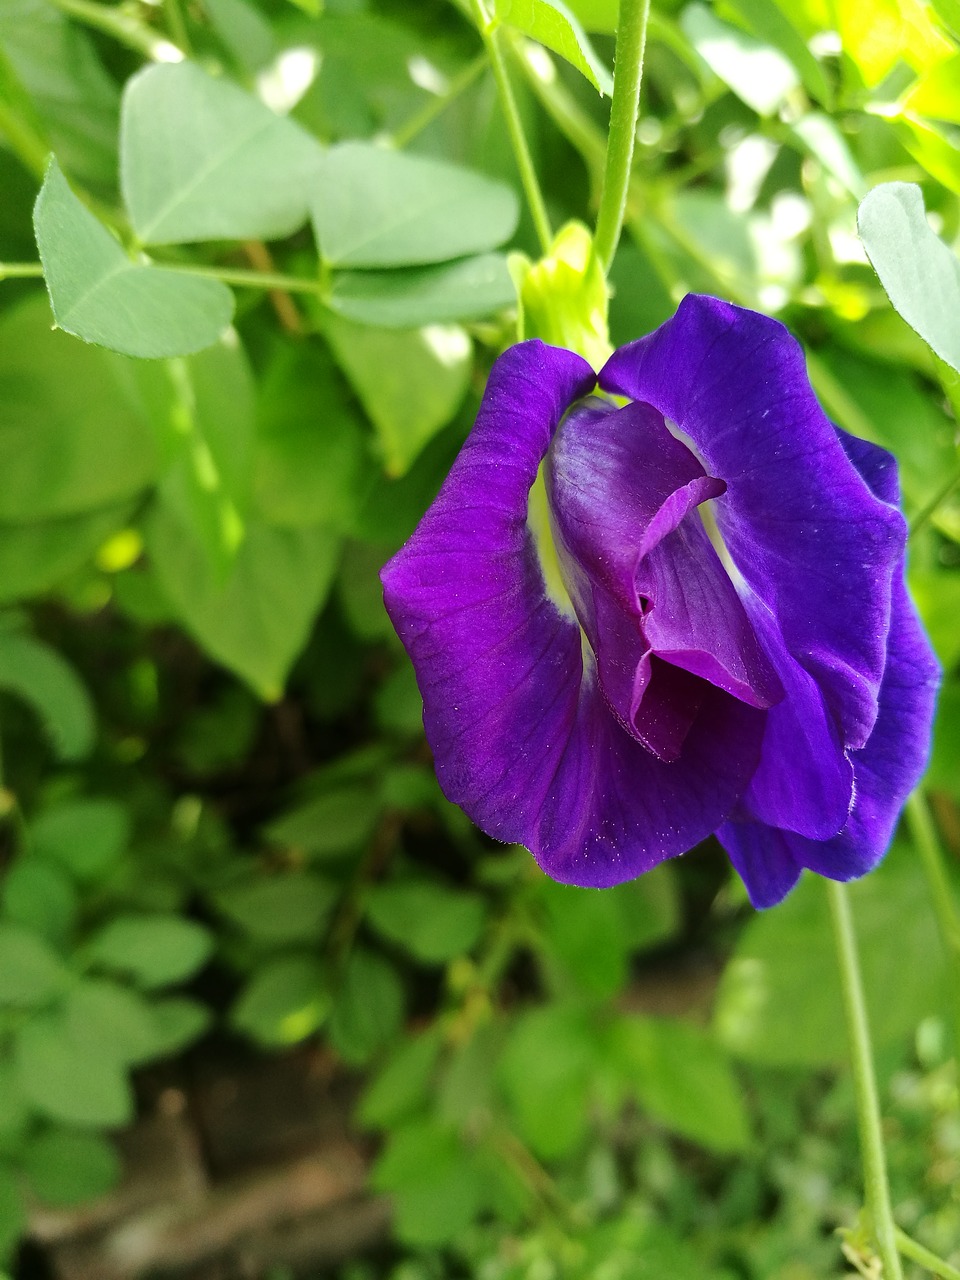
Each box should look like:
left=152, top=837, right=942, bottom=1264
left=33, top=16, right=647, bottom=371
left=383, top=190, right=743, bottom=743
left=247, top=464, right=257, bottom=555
left=33, top=159, right=233, bottom=358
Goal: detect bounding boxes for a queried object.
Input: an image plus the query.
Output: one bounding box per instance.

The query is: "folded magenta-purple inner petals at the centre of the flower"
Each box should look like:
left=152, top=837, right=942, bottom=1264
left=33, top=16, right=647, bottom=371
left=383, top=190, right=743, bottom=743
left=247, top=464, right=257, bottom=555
left=544, top=397, right=782, bottom=760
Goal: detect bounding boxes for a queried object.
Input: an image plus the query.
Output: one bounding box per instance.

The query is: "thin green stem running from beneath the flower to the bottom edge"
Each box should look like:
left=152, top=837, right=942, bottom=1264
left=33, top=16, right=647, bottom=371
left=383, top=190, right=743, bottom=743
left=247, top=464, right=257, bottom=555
left=826, top=881, right=904, bottom=1280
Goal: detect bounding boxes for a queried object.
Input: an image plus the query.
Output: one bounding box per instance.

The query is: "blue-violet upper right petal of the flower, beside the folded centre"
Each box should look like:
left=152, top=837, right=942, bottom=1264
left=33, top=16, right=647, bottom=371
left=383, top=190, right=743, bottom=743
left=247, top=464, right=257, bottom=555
left=600, top=294, right=904, bottom=748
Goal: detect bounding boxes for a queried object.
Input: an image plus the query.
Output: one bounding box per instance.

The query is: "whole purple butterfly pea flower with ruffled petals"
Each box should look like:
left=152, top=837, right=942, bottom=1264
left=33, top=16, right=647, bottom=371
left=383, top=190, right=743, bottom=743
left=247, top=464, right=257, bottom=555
left=383, top=296, right=937, bottom=906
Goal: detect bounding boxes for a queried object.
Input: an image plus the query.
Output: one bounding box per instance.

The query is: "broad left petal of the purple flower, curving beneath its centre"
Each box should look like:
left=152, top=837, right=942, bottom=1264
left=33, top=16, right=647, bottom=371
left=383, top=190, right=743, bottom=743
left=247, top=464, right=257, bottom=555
left=383, top=342, right=764, bottom=884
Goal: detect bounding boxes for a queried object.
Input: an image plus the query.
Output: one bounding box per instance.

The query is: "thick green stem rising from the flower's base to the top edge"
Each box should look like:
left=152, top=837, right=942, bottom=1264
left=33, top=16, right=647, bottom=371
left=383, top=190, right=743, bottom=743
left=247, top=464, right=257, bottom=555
left=596, top=0, right=650, bottom=274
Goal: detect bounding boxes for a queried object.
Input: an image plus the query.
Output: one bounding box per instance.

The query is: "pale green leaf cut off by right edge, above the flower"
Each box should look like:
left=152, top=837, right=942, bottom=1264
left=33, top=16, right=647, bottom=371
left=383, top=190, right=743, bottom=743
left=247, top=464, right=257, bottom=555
left=858, top=182, right=960, bottom=371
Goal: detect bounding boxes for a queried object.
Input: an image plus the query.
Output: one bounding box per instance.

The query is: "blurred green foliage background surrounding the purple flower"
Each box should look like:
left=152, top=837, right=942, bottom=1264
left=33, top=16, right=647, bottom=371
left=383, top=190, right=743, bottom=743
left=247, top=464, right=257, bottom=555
left=0, top=0, right=960, bottom=1280
